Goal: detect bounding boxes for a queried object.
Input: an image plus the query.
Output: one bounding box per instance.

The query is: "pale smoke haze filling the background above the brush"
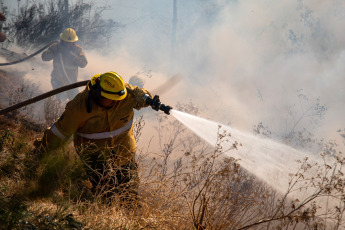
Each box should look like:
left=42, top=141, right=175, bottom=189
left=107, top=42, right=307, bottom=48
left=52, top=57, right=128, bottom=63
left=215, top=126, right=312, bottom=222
left=4, top=0, right=345, bottom=149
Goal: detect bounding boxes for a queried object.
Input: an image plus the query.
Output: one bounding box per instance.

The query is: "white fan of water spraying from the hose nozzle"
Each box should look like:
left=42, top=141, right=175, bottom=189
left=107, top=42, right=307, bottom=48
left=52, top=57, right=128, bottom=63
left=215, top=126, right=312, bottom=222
left=170, top=109, right=328, bottom=196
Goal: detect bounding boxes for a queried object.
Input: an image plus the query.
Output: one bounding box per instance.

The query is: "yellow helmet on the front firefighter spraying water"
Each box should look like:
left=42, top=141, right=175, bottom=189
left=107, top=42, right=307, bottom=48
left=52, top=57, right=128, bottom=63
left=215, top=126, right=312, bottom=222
left=91, top=71, right=127, bottom=101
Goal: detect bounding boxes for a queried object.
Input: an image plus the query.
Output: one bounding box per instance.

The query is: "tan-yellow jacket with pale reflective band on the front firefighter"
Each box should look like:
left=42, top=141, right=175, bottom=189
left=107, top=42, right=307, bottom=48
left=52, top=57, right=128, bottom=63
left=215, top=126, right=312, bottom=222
left=41, top=83, right=151, bottom=166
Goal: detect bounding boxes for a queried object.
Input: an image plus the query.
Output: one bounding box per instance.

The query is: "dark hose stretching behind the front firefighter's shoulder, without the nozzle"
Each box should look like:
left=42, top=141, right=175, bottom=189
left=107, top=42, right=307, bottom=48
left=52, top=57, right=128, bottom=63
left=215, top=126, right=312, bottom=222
left=0, top=80, right=90, bottom=115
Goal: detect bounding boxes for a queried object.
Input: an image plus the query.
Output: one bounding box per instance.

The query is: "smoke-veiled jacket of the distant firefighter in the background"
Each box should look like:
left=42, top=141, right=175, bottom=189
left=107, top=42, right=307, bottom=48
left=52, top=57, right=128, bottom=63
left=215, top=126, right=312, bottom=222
left=42, top=42, right=87, bottom=87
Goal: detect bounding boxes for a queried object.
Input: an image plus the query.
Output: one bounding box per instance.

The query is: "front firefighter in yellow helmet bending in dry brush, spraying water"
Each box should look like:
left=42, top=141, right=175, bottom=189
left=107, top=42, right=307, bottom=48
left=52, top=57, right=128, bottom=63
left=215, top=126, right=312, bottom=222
left=35, top=72, right=151, bottom=201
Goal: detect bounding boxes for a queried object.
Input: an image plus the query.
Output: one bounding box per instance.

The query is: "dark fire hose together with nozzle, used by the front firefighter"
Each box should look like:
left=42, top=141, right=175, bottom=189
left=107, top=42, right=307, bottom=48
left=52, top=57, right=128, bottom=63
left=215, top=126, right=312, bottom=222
left=0, top=80, right=172, bottom=115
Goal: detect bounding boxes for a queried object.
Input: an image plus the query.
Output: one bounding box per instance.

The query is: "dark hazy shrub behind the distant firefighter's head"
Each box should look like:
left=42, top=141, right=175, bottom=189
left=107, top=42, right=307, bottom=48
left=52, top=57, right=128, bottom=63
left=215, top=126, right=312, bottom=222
left=8, top=0, right=123, bottom=49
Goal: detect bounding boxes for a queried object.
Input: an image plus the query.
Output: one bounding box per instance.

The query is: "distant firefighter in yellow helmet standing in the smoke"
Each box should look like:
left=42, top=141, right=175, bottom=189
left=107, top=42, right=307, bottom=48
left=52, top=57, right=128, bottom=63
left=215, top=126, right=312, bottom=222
left=42, top=28, right=87, bottom=102
